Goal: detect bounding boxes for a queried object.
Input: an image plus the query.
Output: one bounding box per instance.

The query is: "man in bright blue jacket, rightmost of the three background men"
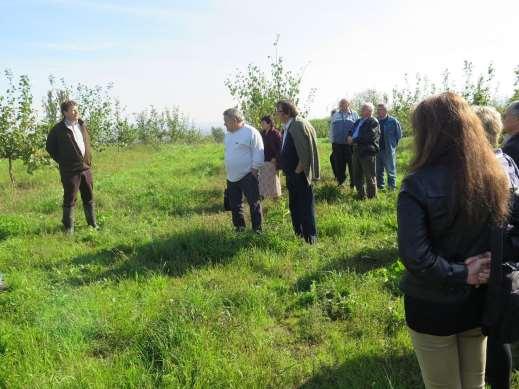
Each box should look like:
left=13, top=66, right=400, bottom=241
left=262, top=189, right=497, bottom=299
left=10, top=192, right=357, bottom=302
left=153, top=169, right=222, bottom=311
left=377, top=104, right=402, bottom=190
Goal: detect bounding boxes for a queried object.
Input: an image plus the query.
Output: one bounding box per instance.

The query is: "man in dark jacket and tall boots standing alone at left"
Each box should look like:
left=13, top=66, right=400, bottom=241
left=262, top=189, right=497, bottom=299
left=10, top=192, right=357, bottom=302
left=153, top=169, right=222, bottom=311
left=46, top=100, right=97, bottom=234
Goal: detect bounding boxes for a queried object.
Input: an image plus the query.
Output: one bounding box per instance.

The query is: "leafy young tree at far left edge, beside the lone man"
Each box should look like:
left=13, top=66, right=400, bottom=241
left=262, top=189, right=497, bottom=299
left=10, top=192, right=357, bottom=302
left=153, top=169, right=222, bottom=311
left=0, top=71, right=44, bottom=186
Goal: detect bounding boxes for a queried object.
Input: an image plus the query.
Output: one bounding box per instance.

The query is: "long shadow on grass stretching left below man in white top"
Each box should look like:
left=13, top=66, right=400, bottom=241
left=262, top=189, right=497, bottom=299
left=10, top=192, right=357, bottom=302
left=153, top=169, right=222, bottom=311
left=64, top=229, right=271, bottom=286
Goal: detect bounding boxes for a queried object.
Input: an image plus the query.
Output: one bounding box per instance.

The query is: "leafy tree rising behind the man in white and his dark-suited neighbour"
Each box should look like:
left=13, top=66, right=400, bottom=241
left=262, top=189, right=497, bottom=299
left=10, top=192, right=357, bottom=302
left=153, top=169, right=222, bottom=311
left=225, top=35, right=315, bottom=127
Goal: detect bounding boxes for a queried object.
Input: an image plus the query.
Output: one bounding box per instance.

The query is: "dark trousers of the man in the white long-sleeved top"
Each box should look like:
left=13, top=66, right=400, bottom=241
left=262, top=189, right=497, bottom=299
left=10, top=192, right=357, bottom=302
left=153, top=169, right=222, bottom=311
left=227, top=173, right=263, bottom=231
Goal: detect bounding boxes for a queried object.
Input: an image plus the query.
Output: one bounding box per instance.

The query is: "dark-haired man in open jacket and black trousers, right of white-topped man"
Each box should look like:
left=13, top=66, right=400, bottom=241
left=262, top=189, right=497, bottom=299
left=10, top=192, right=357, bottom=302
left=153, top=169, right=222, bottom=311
left=276, top=100, right=319, bottom=244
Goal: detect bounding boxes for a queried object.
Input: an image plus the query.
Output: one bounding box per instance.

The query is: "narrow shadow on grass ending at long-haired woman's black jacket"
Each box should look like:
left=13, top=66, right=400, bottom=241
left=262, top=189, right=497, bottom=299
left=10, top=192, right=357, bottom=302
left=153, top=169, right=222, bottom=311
left=294, top=247, right=398, bottom=291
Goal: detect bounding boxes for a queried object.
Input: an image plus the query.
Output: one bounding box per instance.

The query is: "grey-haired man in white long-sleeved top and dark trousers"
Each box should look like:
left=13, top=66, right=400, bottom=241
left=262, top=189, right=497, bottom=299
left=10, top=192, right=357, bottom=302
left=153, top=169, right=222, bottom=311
left=223, top=108, right=264, bottom=232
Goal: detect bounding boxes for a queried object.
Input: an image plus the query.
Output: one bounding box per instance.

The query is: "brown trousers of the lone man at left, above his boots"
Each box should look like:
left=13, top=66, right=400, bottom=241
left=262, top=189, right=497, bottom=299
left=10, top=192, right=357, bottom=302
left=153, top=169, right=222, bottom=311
left=60, top=169, right=94, bottom=208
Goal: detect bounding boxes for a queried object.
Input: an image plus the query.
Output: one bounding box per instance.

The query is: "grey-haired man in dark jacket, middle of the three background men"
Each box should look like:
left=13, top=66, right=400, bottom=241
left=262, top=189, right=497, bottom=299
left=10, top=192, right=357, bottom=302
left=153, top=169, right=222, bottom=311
left=348, top=103, right=380, bottom=200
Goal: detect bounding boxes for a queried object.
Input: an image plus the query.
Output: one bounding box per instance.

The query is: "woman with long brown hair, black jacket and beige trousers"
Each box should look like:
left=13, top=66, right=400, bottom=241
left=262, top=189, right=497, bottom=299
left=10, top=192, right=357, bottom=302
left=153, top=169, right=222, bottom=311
left=398, top=92, right=510, bottom=388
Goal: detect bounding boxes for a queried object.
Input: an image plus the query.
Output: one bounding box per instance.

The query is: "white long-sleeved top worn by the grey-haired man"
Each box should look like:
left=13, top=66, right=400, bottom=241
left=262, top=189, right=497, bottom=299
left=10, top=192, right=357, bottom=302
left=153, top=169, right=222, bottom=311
left=224, top=125, right=265, bottom=182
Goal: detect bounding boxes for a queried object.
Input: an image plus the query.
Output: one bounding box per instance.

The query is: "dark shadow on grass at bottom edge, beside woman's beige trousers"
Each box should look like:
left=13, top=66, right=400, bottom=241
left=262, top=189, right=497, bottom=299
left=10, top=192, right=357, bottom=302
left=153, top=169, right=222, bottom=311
left=299, top=353, right=423, bottom=389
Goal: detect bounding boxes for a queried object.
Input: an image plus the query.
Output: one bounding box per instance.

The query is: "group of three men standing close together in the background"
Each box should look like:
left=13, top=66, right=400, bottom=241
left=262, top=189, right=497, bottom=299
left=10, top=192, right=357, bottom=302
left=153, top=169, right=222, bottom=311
left=329, top=99, right=402, bottom=199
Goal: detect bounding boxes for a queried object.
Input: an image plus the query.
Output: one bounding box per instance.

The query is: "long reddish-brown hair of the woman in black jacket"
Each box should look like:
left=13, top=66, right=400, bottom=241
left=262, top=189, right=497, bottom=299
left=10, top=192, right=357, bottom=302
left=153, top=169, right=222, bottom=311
left=411, top=92, right=510, bottom=224
